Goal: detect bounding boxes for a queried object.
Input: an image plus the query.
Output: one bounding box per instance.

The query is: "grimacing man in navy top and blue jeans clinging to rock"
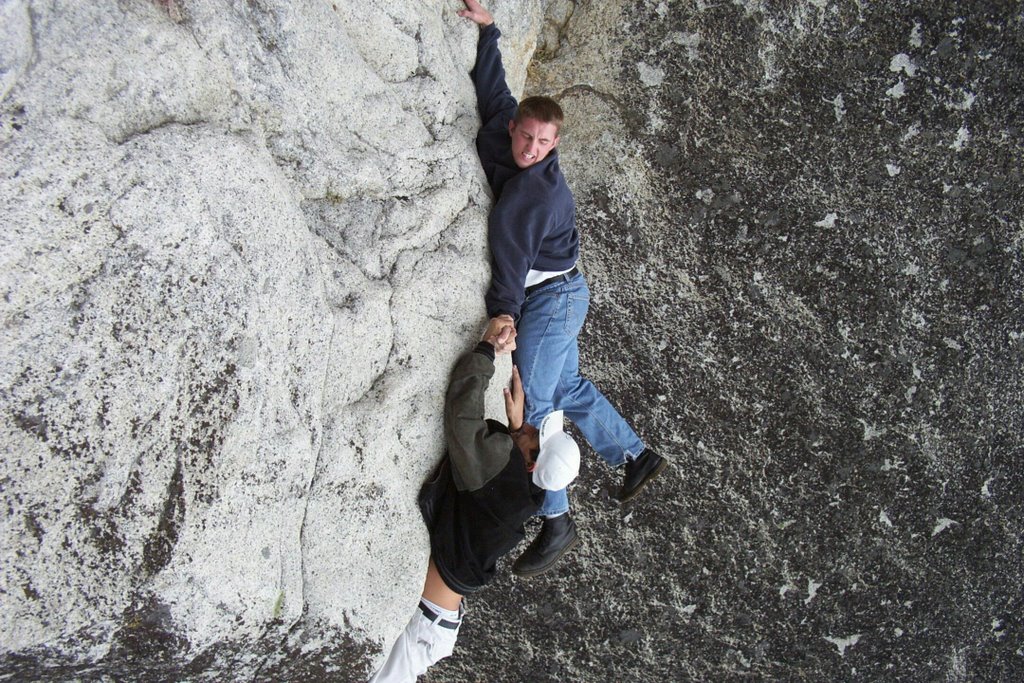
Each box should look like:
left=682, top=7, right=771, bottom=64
left=459, top=0, right=667, bottom=577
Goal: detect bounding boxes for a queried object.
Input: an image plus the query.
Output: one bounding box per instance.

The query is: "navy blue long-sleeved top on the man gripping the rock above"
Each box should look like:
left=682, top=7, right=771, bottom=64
left=471, top=24, right=580, bottom=321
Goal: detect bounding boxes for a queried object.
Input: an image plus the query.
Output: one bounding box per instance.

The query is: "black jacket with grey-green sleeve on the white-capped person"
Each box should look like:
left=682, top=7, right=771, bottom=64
left=419, top=342, right=544, bottom=595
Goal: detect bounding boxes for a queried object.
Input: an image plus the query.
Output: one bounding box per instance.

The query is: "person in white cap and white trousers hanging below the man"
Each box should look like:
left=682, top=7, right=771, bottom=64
left=370, top=319, right=580, bottom=683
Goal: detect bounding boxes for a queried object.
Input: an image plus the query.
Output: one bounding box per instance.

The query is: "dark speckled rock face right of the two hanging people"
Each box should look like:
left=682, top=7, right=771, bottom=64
left=427, top=0, right=1024, bottom=683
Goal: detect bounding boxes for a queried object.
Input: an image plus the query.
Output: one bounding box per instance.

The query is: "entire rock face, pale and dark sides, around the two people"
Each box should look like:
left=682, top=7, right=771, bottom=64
left=0, top=0, right=1024, bottom=681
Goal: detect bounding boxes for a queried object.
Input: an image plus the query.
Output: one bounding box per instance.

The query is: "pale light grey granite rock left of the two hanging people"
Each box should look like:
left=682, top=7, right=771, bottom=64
left=0, top=0, right=541, bottom=675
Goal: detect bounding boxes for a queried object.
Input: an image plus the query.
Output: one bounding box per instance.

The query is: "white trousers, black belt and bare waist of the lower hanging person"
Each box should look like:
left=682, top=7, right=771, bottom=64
left=370, top=559, right=462, bottom=683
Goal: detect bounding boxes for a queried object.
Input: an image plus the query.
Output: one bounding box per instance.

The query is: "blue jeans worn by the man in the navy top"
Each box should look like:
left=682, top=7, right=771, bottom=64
left=512, top=273, right=644, bottom=515
